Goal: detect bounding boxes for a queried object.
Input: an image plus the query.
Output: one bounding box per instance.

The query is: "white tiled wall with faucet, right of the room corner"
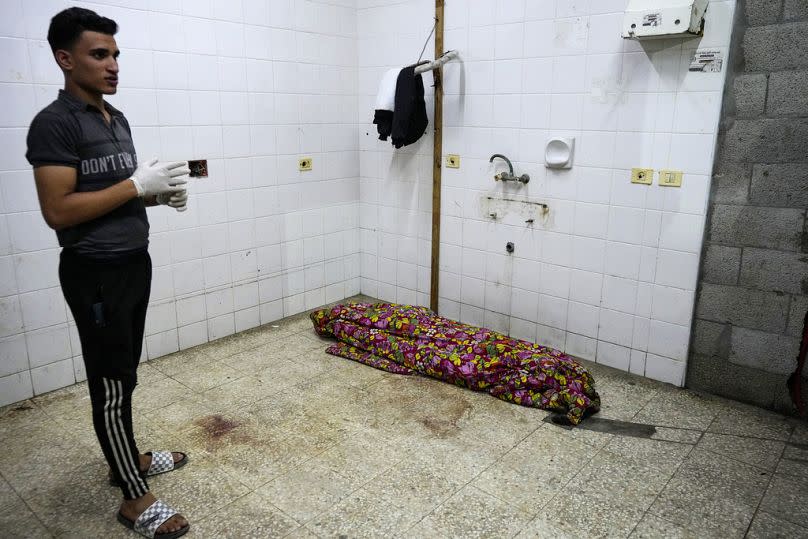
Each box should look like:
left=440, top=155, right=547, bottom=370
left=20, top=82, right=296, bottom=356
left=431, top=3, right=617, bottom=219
left=358, top=0, right=735, bottom=385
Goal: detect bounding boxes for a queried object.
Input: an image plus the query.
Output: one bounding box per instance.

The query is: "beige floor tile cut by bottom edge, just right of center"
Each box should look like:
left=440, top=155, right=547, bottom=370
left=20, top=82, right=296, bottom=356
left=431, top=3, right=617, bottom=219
left=410, top=486, right=533, bottom=538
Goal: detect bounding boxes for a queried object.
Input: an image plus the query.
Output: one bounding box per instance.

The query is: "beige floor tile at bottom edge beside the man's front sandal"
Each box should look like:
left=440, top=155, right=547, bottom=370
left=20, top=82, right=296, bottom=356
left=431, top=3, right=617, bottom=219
left=189, top=493, right=300, bottom=539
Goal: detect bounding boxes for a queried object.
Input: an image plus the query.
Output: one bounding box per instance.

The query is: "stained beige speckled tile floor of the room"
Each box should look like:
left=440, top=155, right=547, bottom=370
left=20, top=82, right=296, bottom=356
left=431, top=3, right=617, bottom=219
left=0, top=298, right=808, bottom=538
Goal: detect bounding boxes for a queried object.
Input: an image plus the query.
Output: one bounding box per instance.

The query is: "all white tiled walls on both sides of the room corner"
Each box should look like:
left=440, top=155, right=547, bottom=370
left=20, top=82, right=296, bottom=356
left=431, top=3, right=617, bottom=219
left=0, top=0, right=734, bottom=405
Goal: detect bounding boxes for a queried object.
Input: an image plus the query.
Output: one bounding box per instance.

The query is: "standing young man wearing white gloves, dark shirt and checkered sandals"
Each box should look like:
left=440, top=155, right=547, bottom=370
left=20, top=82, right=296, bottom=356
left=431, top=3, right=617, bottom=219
left=26, top=7, right=189, bottom=539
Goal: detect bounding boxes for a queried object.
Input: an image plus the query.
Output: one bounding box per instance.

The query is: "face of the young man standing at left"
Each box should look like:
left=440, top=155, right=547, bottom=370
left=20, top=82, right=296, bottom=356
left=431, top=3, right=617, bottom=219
left=56, top=30, right=120, bottom=95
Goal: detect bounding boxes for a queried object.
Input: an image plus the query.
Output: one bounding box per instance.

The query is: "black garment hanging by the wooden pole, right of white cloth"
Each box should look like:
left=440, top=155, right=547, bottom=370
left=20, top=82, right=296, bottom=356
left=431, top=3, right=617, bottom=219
left=391, top=66, right=429, bottom=148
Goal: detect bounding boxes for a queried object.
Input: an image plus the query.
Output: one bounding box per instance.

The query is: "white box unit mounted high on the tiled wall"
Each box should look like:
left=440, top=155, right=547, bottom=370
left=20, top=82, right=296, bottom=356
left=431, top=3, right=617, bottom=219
left=623, top=0, right=710, bottom=39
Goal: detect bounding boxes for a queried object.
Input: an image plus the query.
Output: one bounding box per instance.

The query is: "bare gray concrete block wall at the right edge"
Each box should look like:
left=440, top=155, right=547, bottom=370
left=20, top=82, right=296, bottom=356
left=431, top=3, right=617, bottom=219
left=687, top=0, right=808, bottom=413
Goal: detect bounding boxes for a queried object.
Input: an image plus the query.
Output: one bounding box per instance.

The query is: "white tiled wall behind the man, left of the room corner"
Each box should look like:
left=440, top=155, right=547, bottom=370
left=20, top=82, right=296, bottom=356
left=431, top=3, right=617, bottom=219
left=0, top=0, right=360, bottom=405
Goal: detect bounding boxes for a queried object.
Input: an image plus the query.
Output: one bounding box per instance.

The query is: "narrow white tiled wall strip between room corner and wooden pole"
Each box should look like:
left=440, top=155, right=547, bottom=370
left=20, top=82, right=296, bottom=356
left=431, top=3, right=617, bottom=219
left=357, top=0, right=438, bottom=305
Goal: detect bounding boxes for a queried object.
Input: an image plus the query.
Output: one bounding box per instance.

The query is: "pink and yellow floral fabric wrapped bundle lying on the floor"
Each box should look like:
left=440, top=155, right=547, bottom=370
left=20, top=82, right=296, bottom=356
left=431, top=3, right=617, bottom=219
left=311, top=303, right=600, bottom=425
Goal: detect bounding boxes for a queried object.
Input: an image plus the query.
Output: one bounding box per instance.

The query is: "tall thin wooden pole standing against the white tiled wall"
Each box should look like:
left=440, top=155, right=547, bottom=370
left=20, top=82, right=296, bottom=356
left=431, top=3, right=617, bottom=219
left=429, top=0, right=443, bottom=313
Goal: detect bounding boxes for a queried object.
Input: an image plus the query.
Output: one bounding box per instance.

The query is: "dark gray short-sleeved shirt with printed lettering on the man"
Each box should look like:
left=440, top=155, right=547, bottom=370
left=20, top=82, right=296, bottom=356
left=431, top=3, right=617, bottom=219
left=25, top=90, right=149, bottom=258
